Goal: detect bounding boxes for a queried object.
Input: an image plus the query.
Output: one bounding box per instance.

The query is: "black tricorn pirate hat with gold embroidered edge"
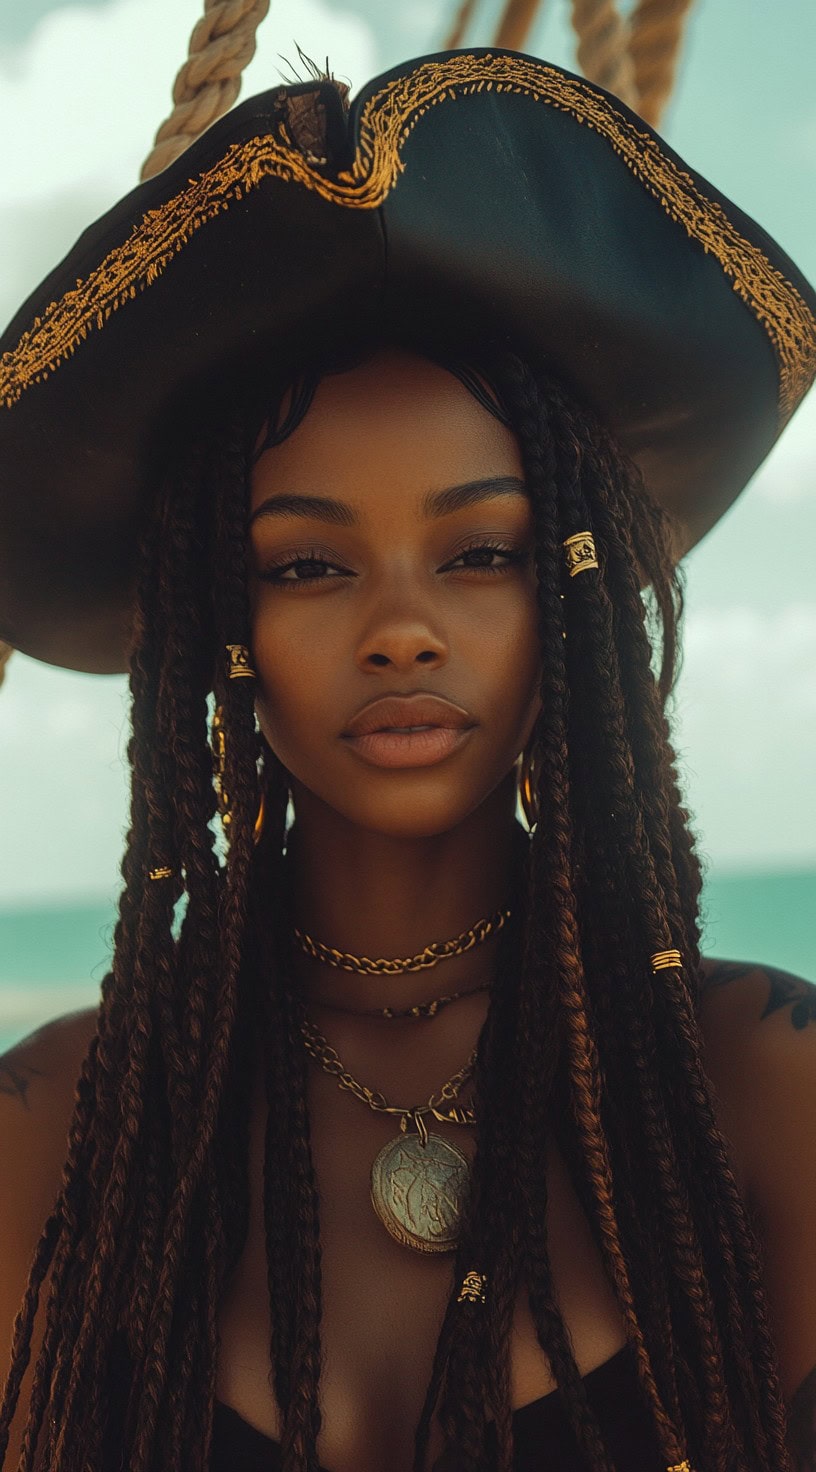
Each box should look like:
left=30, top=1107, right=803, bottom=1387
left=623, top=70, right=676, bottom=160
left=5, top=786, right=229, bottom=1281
left=0, top=50, right=816, bottom=673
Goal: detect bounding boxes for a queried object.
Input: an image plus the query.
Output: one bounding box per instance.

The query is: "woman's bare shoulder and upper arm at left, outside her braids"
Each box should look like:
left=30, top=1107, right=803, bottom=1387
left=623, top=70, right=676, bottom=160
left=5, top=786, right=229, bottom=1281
left=0, top=1007, right=97, bottom=1468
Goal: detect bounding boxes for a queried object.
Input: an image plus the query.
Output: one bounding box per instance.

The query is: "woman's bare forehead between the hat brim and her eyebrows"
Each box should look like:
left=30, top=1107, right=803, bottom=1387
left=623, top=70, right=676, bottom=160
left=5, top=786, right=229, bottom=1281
left=244, top=349, right=521, bottom=506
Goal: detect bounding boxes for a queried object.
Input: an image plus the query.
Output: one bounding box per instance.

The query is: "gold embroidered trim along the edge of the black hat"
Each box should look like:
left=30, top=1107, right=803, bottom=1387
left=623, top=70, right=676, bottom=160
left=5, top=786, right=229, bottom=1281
left=0, top=53, right=816, bottom=425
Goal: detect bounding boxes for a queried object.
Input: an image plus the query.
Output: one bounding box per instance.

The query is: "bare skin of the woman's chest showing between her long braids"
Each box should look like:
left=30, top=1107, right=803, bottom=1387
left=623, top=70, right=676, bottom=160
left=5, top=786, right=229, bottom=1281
left=217, top=1075, right=625, bottom=1472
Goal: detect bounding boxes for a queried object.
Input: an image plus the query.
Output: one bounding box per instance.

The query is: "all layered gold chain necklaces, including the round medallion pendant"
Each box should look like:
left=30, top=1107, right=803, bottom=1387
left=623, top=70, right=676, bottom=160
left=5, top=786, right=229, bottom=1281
left=293, top=910, right=511, bottom=1253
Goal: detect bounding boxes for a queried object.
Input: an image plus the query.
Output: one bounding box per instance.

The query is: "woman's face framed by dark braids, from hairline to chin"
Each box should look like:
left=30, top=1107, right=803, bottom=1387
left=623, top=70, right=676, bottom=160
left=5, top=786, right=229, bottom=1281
left=249, top=349, right=539, bottom=838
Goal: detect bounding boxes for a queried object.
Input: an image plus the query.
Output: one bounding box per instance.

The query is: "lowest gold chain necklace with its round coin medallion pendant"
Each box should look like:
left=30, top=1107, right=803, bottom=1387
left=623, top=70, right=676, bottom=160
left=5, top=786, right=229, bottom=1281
left=300, top=1017, right=477, bottom=1253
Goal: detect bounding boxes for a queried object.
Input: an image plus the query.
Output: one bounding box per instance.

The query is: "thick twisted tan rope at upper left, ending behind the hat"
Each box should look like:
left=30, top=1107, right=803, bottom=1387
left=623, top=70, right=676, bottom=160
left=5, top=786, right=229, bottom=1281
left=138, top=0, right=270, bottom=180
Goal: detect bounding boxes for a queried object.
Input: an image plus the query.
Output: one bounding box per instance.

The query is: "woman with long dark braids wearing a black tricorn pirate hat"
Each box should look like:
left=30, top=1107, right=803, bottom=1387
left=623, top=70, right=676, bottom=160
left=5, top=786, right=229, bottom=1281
left=0, top=53, right=816, bottom=1472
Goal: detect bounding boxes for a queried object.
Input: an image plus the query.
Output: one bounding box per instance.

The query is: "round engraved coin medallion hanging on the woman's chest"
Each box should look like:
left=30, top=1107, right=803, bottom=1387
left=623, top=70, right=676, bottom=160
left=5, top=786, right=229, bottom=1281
left=371, top=1133, right=470, bottom=1253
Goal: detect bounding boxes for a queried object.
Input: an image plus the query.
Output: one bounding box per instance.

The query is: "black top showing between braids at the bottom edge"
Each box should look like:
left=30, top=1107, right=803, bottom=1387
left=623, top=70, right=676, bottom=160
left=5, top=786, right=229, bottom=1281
left=209, top=1344, right=666, bottom=1472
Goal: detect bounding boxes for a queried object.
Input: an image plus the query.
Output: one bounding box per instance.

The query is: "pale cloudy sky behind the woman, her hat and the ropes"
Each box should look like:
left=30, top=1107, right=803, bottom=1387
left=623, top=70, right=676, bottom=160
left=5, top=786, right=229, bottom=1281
left=0, top=0, right=816, bottom=908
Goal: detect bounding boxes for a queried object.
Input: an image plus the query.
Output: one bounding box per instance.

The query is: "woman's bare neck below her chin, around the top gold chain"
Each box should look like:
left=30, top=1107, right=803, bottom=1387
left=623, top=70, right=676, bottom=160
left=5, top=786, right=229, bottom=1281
left=276, top=773, right=523, bottom=1010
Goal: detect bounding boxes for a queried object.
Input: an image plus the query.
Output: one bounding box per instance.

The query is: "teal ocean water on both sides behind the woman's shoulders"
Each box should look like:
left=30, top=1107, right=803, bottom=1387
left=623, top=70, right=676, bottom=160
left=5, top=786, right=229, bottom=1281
left=0, top=868, right=816, bottom=1052
